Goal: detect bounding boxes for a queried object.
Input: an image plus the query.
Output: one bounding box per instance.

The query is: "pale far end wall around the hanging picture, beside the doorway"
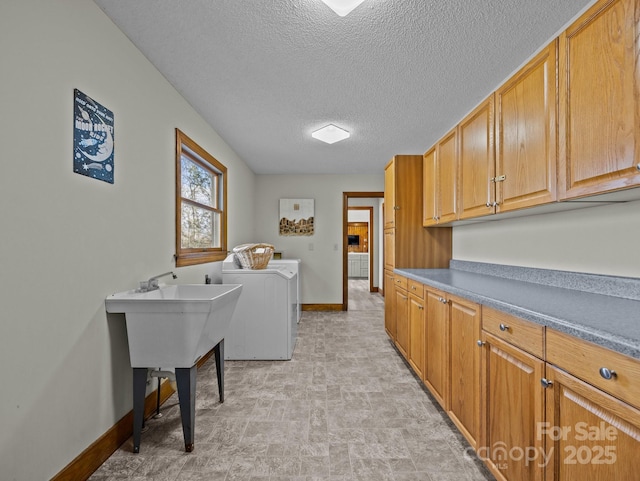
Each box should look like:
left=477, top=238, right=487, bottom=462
left=255, top=172, right=384, bottom=304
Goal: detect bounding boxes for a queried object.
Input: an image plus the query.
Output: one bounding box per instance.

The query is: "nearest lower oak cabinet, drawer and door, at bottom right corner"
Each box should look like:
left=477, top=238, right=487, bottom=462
left=543, top=329, right=640, bottom=481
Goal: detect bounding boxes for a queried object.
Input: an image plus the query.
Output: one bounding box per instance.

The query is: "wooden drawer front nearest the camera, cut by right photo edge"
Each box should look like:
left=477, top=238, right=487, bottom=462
left=547, top=329, right=640, bottom=408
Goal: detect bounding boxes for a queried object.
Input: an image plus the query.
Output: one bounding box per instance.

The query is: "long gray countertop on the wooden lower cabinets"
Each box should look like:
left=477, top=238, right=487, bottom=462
left=395, top=269, right=640, bottom=359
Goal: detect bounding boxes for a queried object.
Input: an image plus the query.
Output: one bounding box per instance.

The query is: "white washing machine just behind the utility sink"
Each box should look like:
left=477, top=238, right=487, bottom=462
left=222, top=254, right=298, bottom=360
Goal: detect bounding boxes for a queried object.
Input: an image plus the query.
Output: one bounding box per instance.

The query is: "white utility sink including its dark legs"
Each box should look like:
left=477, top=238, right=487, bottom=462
left=104, top=284, right=242, bottom=453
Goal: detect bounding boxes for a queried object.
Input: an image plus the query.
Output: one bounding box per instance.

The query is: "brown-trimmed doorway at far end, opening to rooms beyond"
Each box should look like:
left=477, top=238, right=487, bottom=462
left=342, top=192, right=384, bottom=311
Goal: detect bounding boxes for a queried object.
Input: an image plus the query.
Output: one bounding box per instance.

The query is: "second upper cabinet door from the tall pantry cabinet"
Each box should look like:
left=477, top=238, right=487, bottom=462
left=436, top=129, right=458, bottom=223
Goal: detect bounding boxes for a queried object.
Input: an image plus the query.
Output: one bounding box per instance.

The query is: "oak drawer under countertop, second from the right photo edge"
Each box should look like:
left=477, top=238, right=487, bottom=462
left=482, top=306, right=544, bottom=359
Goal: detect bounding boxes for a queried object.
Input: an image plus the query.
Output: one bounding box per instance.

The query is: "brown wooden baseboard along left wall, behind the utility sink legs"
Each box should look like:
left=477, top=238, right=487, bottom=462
left=51, top=351, right=213, bottom=481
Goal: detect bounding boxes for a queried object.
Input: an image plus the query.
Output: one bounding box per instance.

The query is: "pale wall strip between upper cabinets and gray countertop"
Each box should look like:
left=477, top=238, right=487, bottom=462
left=453, top=201, right=640, bottom=277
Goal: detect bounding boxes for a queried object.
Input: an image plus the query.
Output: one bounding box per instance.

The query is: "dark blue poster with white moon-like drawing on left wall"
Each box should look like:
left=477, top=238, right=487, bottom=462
left=73, top=89, right=114, bottom=184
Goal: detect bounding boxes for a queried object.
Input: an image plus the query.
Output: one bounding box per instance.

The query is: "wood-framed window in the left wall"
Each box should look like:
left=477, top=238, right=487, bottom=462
left=176, top=129, right=227, bottom=267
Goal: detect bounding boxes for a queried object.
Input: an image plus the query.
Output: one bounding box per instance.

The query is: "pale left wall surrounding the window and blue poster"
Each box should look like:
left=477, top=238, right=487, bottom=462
left=0, top=0, right=255, bottom=480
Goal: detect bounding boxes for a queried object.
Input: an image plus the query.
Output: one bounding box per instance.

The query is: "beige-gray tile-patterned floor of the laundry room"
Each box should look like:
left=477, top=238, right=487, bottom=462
left=90, top=284, right=493, bottom=481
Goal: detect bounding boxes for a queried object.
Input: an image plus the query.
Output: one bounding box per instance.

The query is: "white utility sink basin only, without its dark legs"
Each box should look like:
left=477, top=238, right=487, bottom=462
left=105, top=284, right=242, bottom=368
